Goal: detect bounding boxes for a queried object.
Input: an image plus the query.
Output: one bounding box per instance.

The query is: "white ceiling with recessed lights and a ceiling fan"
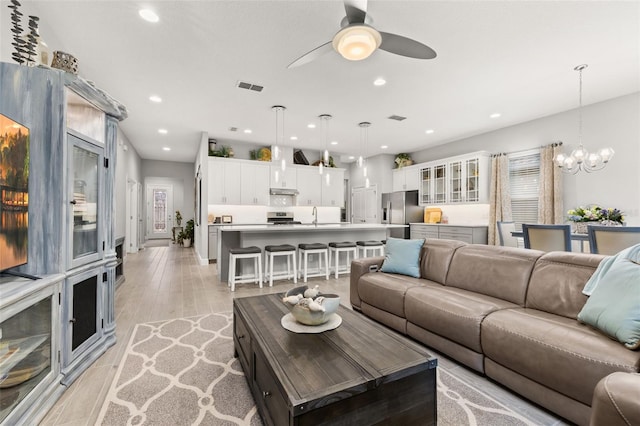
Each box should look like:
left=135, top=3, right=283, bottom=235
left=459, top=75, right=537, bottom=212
left=0, top=0, right=640, bottom=162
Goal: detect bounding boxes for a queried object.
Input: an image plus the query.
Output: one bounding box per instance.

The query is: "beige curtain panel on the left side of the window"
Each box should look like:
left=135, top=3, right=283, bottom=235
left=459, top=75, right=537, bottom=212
left=489, top=154, right=512, bottom=245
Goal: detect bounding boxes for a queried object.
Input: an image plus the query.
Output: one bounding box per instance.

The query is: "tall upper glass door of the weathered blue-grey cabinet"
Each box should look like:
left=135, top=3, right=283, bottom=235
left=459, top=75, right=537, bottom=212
left=68, top=134, right=103, bottom=266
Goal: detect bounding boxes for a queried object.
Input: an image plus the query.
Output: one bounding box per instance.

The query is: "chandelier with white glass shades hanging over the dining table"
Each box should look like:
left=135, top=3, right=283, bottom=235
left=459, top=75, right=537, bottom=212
left=554, top=64, right=614, bottom=174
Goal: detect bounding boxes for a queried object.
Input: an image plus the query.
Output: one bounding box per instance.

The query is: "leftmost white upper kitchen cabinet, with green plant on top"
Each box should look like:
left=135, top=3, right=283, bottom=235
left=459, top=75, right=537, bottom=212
left=208, top=157, right=242, bottom=204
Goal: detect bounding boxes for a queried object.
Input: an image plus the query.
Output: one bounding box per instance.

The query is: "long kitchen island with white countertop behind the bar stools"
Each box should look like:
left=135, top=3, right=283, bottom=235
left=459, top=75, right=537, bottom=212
left=218, top=223, right=408, bottom=282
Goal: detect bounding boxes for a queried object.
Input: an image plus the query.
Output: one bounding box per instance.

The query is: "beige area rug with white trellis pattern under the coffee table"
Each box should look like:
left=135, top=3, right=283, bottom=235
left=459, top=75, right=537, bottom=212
left=98, top=313, right=539, bottom=426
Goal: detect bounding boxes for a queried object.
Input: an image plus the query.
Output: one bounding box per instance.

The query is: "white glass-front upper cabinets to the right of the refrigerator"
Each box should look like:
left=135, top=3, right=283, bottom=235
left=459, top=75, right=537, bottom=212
left=420, top=152, right=491, bottom=206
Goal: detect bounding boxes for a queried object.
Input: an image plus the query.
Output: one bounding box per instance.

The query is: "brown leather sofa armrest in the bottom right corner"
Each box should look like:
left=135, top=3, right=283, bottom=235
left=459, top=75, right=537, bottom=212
left=589, top=372, right=640, bottom=426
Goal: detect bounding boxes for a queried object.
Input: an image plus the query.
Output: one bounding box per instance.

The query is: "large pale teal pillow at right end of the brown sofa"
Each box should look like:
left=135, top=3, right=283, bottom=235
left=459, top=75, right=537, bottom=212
left=578, top=244, right=640, bottom=350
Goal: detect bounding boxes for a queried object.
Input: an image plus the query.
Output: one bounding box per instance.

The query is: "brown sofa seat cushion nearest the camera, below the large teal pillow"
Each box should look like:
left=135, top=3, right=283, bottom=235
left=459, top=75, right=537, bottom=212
left=481, top=308, right=640, bottom=405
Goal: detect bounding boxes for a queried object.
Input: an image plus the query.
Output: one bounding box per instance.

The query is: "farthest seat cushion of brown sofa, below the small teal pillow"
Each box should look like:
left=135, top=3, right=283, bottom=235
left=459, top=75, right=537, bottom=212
left=358, top=272, right=429, bottom=318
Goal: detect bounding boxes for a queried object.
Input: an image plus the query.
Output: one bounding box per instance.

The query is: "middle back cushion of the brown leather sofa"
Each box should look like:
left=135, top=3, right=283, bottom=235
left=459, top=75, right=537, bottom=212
left=445, top=244, right=544, bottom=306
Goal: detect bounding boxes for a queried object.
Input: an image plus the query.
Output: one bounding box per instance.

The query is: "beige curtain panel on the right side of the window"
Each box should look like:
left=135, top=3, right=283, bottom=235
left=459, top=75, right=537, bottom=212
left=538, top=143, right=564, bottom=224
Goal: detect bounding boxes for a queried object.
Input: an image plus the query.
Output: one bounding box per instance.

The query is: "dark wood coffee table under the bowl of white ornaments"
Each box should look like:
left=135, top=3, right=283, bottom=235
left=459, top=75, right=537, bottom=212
left=233, top=294, right=437, bottom=426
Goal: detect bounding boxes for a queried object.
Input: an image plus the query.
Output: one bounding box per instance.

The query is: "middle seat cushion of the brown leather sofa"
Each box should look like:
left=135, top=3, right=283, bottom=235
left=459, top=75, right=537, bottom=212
left=405, top=285, right=517, bottom=353
